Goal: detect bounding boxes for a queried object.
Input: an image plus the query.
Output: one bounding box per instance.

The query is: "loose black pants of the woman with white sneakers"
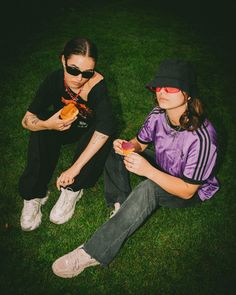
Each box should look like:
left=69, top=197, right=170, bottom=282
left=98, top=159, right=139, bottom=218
left=19, top=127, right=112, bottom=200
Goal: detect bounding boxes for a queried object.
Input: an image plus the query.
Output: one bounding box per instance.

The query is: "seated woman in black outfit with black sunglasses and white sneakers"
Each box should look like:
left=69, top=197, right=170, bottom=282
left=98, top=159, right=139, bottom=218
left=19, top=38, right=114, bottom=231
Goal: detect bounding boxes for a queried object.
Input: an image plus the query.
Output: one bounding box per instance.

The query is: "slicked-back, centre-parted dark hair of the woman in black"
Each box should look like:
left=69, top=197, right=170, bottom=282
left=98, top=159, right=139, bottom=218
left=61, top=38, right=98, bottom=63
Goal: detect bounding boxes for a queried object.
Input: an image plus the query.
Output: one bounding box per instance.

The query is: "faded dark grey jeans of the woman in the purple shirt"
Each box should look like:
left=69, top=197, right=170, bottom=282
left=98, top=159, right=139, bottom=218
left=84, top=152, right=201, bottom=265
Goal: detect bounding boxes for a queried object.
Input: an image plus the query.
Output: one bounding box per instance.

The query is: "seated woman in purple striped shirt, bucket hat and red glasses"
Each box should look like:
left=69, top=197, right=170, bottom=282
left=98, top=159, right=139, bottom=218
left=52, top=60, right=219, bottom=277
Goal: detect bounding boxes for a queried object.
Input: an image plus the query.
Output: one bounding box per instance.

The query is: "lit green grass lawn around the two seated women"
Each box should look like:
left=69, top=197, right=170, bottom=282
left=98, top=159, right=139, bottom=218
left=0, top=0, right=236, bottom=295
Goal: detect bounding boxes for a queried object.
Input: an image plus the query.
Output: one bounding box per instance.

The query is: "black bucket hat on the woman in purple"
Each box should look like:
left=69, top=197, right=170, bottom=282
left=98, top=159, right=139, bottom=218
left=147, top=59, right=198, bottom=98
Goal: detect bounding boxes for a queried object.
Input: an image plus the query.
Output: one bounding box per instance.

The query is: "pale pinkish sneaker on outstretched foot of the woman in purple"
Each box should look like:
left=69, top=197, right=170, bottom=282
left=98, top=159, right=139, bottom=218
left=52, top=246, right=100, bottom=278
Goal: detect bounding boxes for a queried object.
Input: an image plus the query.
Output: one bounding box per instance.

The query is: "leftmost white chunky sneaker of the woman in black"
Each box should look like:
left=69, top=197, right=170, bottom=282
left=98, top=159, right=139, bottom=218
left=20, top=192, right=49, bottom=231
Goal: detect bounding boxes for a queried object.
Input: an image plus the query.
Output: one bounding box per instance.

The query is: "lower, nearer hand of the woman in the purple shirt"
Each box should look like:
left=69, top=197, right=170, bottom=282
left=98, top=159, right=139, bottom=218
left=124, top=153, right=152, bottom=178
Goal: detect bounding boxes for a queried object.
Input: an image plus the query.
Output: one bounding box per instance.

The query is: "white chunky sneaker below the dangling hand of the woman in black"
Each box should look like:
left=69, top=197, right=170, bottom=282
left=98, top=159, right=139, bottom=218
left=50, top=188, right=83, bottom=224
